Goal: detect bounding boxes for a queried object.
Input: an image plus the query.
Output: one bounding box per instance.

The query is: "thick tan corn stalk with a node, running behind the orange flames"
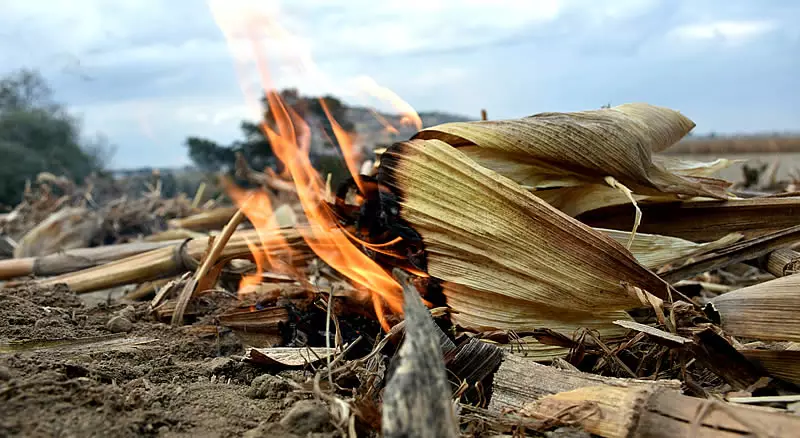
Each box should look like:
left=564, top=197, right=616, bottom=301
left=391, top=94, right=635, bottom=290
left=33, top=228, right=308, bottom=294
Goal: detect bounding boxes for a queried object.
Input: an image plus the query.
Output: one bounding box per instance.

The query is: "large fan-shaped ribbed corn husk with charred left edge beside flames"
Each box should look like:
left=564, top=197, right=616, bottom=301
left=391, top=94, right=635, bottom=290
left=379, top=140, right=668, bottom=316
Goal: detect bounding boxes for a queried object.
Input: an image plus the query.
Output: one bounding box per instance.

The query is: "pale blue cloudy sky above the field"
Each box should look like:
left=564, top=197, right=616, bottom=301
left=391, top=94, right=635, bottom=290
left=0, top=0, right=800, bottom=168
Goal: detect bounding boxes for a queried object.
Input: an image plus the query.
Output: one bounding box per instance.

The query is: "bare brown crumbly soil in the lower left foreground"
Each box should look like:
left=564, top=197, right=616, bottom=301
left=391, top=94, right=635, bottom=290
left=0, top=286, right=335, bottom=437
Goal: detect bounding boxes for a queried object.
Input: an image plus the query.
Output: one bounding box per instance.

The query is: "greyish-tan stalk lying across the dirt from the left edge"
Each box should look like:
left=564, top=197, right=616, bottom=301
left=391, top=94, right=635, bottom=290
left=0, top=240, right=182, bottom=280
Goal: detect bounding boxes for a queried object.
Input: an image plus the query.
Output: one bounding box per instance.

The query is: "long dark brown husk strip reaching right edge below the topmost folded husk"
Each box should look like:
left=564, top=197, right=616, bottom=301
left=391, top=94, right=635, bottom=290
left=578, top=196, right=800, bottom=242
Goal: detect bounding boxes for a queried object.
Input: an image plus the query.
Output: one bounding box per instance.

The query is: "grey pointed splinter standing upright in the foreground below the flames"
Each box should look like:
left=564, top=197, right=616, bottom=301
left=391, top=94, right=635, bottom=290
left=382, top=269, right=459, bottom=438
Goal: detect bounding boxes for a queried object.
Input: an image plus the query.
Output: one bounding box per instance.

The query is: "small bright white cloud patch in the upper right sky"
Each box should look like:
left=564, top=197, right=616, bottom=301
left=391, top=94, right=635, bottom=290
left=670, top=20, right=777, bottom=44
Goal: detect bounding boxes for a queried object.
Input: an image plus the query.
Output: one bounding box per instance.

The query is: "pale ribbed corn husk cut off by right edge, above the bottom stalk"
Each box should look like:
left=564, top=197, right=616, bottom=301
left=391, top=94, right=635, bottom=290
left=711, top=275, right=800, bottom=342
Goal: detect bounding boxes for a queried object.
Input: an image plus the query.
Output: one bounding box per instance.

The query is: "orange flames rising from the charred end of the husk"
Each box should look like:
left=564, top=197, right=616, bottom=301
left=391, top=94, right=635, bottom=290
left=211, top=3, right=421, bottom=330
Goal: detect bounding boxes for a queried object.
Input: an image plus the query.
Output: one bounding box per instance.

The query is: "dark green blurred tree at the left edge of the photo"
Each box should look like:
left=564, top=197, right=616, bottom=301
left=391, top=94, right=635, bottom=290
left=0, top=70, right=112, bottom=205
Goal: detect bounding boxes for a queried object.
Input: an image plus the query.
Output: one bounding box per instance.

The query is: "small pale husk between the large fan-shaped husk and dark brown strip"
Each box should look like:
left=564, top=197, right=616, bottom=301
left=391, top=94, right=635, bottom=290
left=597, top=228, right=744, bottom=269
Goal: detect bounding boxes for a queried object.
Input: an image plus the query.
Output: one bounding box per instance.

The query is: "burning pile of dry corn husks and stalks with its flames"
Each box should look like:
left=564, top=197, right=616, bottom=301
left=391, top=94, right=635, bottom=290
left=0, top=5, right=800, bottom=437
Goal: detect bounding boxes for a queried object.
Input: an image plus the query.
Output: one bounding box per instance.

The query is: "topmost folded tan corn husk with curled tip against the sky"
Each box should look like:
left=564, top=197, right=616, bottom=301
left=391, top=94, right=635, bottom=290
left=414, top=103, right=730, bottom=199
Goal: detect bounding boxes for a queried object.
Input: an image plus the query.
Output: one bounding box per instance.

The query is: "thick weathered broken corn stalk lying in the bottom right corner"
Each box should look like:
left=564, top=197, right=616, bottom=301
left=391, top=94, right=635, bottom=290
left=485, top=356, right=800, bottom=438
